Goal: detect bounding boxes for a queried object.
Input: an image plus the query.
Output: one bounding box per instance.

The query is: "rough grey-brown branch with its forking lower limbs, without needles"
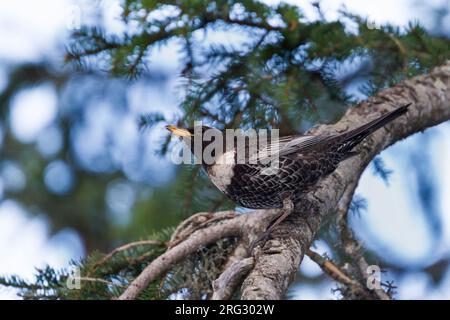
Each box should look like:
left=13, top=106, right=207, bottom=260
left=119, top=61, right=450, bottom=299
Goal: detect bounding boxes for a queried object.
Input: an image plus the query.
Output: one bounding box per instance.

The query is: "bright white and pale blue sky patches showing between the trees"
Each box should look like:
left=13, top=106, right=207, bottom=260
left=0, top=0, right=450, bottom=299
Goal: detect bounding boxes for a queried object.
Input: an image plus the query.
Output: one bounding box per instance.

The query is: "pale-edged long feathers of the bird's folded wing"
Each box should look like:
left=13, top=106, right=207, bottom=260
left=249, top=135, right=330, bottom=161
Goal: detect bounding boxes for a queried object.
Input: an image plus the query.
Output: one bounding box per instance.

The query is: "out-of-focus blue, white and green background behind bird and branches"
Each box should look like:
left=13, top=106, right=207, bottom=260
left=0, top=0, right=450, bottom=299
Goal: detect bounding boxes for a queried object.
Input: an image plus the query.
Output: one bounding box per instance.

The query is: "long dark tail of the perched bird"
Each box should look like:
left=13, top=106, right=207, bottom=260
left=336, top=103, right=411, bottom=152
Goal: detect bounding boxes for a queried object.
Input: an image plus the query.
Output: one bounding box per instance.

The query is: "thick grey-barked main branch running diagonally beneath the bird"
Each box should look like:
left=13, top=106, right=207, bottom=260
left=241, top=61, right=450, bottom=299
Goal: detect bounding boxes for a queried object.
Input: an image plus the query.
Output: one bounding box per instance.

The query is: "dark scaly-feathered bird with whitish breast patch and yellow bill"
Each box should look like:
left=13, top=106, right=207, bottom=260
left=166, top=104, right=410, bottom=248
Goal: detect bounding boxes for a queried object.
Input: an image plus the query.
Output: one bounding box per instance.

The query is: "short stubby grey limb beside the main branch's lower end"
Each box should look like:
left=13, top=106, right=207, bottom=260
left=211, top=257, right=255, bottom=300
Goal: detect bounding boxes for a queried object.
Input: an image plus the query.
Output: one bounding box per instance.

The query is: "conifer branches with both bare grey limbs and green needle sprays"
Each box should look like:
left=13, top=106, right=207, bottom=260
left=4, top=0, right=450, bottom=299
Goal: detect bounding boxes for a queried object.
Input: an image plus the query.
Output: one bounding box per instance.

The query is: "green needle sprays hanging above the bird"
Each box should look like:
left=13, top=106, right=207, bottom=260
left=66, top=0, right=449, bottom=133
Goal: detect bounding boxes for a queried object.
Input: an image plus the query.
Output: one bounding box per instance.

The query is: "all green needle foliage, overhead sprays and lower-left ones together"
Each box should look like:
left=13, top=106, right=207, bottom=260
left=0, top=0, right=450, bottom=299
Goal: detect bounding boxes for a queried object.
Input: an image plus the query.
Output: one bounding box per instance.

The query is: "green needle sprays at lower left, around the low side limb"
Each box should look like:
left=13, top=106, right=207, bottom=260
left=0, top=228, right=235, bottom=300
